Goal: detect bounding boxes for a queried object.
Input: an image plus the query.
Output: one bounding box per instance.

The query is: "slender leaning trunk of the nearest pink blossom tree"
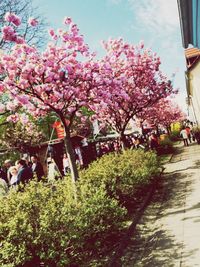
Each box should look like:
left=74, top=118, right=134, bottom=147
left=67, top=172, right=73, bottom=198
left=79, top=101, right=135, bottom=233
left=61, top=119, right=78, bottom=183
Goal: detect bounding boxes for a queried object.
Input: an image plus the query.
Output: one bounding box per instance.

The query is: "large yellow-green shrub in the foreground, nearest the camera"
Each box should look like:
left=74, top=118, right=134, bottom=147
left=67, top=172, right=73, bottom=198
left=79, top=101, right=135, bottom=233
left=0, top=180, right=126, bottom=267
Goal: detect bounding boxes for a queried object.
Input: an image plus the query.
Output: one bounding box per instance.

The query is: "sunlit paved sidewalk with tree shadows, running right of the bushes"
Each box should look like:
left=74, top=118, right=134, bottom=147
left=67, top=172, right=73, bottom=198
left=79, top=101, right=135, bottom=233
left=122, top=144, right=200, bottom=267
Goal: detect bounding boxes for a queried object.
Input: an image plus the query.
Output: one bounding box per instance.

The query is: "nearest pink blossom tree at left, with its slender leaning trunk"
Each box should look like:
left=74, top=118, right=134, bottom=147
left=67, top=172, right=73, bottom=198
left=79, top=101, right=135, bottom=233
left=0, top=17, right=98, bottom=181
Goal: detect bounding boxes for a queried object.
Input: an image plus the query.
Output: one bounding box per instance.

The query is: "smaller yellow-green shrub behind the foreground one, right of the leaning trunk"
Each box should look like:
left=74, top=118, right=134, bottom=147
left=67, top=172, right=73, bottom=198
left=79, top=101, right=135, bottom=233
left=80, top=149, right=159, bottom=200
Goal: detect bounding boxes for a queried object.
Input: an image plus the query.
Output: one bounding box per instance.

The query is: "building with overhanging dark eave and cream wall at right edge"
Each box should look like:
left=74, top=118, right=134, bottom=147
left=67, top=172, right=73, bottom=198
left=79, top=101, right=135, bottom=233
left=177, top=0, right=200, bottom=127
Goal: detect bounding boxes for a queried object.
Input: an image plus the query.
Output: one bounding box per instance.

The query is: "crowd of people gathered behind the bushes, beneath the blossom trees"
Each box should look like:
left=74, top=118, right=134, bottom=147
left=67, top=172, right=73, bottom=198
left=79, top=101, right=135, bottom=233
left=0, top=132, right=165, bottom=197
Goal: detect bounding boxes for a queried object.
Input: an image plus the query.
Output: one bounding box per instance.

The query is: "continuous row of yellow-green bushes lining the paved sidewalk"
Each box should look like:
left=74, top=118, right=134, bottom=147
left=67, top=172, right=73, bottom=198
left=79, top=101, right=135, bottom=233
left=0, top=150, right=159, bottom=267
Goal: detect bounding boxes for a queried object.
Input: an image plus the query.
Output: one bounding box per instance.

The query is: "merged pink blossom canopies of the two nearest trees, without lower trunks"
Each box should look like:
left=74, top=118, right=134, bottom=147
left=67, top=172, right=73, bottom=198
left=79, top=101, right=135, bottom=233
left=0, top=14, right=180, bottom=139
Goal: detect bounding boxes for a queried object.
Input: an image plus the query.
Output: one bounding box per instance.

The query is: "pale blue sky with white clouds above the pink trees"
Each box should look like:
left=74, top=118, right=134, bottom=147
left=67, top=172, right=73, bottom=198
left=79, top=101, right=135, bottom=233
left=33, top=0, right=187, bottom=112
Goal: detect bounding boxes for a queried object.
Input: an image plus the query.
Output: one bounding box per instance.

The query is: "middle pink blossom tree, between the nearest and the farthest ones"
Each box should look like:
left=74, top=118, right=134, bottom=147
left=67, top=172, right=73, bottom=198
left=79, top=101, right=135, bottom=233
left=90, top=39, right=175, bottom=149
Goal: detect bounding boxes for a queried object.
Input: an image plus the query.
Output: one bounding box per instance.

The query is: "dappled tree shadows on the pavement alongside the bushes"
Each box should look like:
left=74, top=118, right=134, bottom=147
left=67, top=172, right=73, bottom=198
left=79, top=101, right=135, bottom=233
left=118, top=161, right=196, bottom=267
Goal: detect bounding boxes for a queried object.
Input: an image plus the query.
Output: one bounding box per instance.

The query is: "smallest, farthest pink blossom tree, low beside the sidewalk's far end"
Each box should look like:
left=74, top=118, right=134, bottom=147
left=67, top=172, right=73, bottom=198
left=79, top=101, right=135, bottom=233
left=137, top=99, right=186, bottom=134
